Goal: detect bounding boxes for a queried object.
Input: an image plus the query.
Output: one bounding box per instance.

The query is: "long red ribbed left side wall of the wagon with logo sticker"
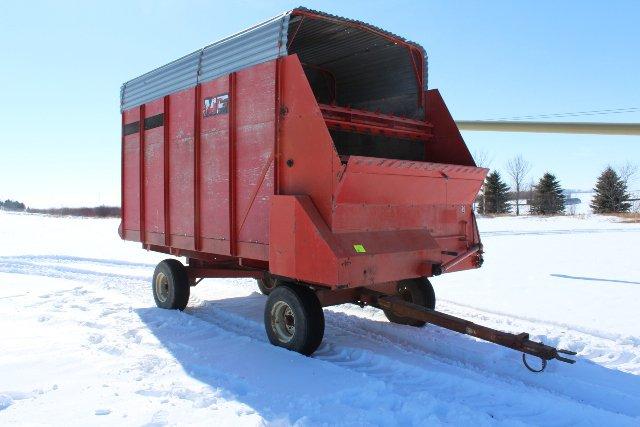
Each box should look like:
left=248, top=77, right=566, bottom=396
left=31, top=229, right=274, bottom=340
left=123, top=61, right=276, bottom=260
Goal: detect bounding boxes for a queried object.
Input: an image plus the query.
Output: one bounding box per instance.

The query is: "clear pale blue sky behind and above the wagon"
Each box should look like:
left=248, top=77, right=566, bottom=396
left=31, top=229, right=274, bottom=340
left=0, top=0, right=640, bottom=207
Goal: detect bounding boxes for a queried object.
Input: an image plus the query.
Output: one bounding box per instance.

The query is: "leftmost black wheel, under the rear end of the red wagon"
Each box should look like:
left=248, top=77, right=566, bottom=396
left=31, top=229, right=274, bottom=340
left=151, top=259, right=191, bottom=310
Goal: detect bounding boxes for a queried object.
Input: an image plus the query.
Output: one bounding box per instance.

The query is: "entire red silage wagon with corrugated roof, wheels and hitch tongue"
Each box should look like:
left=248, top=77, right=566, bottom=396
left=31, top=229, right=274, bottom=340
left=119, top=8, right=576, bottom=372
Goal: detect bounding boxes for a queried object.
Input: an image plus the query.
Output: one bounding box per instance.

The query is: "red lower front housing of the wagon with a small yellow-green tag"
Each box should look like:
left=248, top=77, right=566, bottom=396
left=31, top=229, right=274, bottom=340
left=269, top=196, right=441, bottom=287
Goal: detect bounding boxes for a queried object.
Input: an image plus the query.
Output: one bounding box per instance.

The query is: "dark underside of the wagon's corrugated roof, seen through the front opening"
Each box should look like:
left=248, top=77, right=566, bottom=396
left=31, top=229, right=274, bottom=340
left=288, top=8, right=426, bottom=118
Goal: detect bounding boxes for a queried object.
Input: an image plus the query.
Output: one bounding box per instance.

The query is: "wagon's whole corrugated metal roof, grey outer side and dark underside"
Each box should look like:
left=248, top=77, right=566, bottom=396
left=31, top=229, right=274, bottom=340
left=121, top=7, right=426, bottom=116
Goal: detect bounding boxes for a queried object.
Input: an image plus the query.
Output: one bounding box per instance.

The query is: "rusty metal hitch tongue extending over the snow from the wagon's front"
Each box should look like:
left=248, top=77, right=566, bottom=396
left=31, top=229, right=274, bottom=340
left=376, top=295, right=576, bottom=372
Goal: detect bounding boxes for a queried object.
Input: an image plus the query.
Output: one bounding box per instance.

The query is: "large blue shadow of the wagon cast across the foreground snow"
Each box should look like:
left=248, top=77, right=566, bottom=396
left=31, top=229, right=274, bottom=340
left=137, top=293, right=640, bottom=424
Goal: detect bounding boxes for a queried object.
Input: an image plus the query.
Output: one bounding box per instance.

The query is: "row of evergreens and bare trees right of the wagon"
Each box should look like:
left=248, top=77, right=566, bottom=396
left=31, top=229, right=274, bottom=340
left=477, top=154, right=637, bottom=215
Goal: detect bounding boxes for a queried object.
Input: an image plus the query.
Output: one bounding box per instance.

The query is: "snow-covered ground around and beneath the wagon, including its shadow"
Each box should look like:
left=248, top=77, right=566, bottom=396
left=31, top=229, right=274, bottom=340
left=0, top=212, right=640, bottom=426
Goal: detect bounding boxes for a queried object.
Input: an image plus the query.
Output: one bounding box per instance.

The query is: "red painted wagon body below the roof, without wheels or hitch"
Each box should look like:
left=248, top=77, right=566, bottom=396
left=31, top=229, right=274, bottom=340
left=122, top=44, right=487, bottom=295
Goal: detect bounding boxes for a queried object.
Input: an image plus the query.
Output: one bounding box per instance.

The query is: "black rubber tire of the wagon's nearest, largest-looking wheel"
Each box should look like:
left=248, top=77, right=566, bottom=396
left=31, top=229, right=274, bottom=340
left=264, top=283, right=324, bottom=356
